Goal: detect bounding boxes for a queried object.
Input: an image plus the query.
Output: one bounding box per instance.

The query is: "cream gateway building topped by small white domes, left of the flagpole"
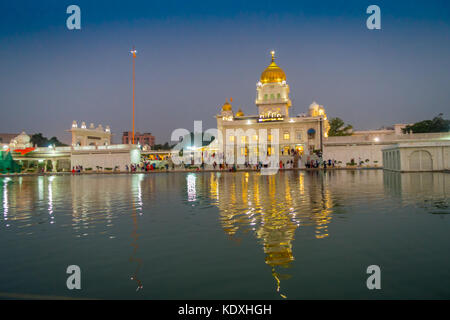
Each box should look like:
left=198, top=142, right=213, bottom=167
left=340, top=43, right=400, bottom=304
left=68, top=120, right=111, bottom=147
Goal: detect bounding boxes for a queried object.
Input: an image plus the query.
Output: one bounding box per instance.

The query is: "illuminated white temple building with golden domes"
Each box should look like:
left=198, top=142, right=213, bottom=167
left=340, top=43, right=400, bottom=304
left=216, top=51, right=329, bottom=164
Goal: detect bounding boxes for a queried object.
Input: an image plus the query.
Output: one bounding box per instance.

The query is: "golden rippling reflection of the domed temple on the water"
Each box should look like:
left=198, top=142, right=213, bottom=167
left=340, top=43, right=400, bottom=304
left=209, top=172, right=333, bottom=297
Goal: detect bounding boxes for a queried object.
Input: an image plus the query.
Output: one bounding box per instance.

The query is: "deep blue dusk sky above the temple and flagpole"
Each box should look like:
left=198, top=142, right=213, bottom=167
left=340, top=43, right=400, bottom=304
left=0, top=0, right=450, bottom=142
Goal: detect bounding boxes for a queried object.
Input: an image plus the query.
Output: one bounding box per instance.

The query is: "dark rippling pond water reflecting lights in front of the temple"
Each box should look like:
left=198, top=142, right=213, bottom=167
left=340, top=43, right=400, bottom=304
left=0, top=170, right=450, bottom=299
